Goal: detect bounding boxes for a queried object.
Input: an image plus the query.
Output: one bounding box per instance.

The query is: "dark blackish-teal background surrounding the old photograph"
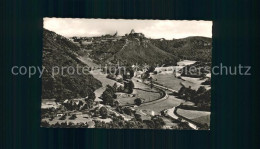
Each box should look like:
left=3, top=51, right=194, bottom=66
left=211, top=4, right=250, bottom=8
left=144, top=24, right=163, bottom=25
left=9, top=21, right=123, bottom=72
left=0, top=0, right=260, bottom=149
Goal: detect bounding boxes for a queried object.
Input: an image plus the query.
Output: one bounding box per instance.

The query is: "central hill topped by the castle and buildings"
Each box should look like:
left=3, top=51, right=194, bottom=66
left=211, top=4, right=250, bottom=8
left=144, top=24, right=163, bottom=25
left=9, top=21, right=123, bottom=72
left=74, top=32, right=179, bottom=65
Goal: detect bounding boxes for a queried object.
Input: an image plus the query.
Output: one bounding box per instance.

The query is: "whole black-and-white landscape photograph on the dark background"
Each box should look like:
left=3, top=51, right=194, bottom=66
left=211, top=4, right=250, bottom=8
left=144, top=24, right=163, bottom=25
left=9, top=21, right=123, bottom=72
left=40, top=18, right=212, bottom=130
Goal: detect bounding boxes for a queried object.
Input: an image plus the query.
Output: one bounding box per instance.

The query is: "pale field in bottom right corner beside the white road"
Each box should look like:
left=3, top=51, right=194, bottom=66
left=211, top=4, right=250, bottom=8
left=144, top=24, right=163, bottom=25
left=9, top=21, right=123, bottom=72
left=177, top=109, right=210, bottom=120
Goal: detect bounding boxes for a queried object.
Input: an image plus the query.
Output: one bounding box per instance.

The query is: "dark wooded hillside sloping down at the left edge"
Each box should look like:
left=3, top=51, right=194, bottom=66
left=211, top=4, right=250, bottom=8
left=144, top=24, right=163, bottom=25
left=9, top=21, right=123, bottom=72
left=42, top=29, right=101, bottom=99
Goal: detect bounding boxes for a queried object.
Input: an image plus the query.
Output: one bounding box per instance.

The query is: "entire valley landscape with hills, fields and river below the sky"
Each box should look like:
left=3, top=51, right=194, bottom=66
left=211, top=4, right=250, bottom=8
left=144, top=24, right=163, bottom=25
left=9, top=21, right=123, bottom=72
left=41, top=30, right=211, bottom=130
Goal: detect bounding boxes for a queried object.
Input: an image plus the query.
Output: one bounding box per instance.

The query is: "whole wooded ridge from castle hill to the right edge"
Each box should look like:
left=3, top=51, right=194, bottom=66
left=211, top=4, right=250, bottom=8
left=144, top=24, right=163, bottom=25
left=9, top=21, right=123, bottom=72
left=74, top=32, right=212, bottom=65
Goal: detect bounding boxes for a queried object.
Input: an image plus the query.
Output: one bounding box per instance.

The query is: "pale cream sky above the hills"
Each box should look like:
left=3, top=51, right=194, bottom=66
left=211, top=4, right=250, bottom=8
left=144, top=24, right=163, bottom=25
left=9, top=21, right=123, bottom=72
left=43, top=18, right=212, bottom=40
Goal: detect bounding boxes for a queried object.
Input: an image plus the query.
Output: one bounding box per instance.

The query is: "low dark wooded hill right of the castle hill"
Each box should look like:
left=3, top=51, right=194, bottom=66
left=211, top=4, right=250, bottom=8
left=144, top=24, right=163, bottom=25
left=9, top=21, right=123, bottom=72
left=151, top=36, right=212, bottom=62
